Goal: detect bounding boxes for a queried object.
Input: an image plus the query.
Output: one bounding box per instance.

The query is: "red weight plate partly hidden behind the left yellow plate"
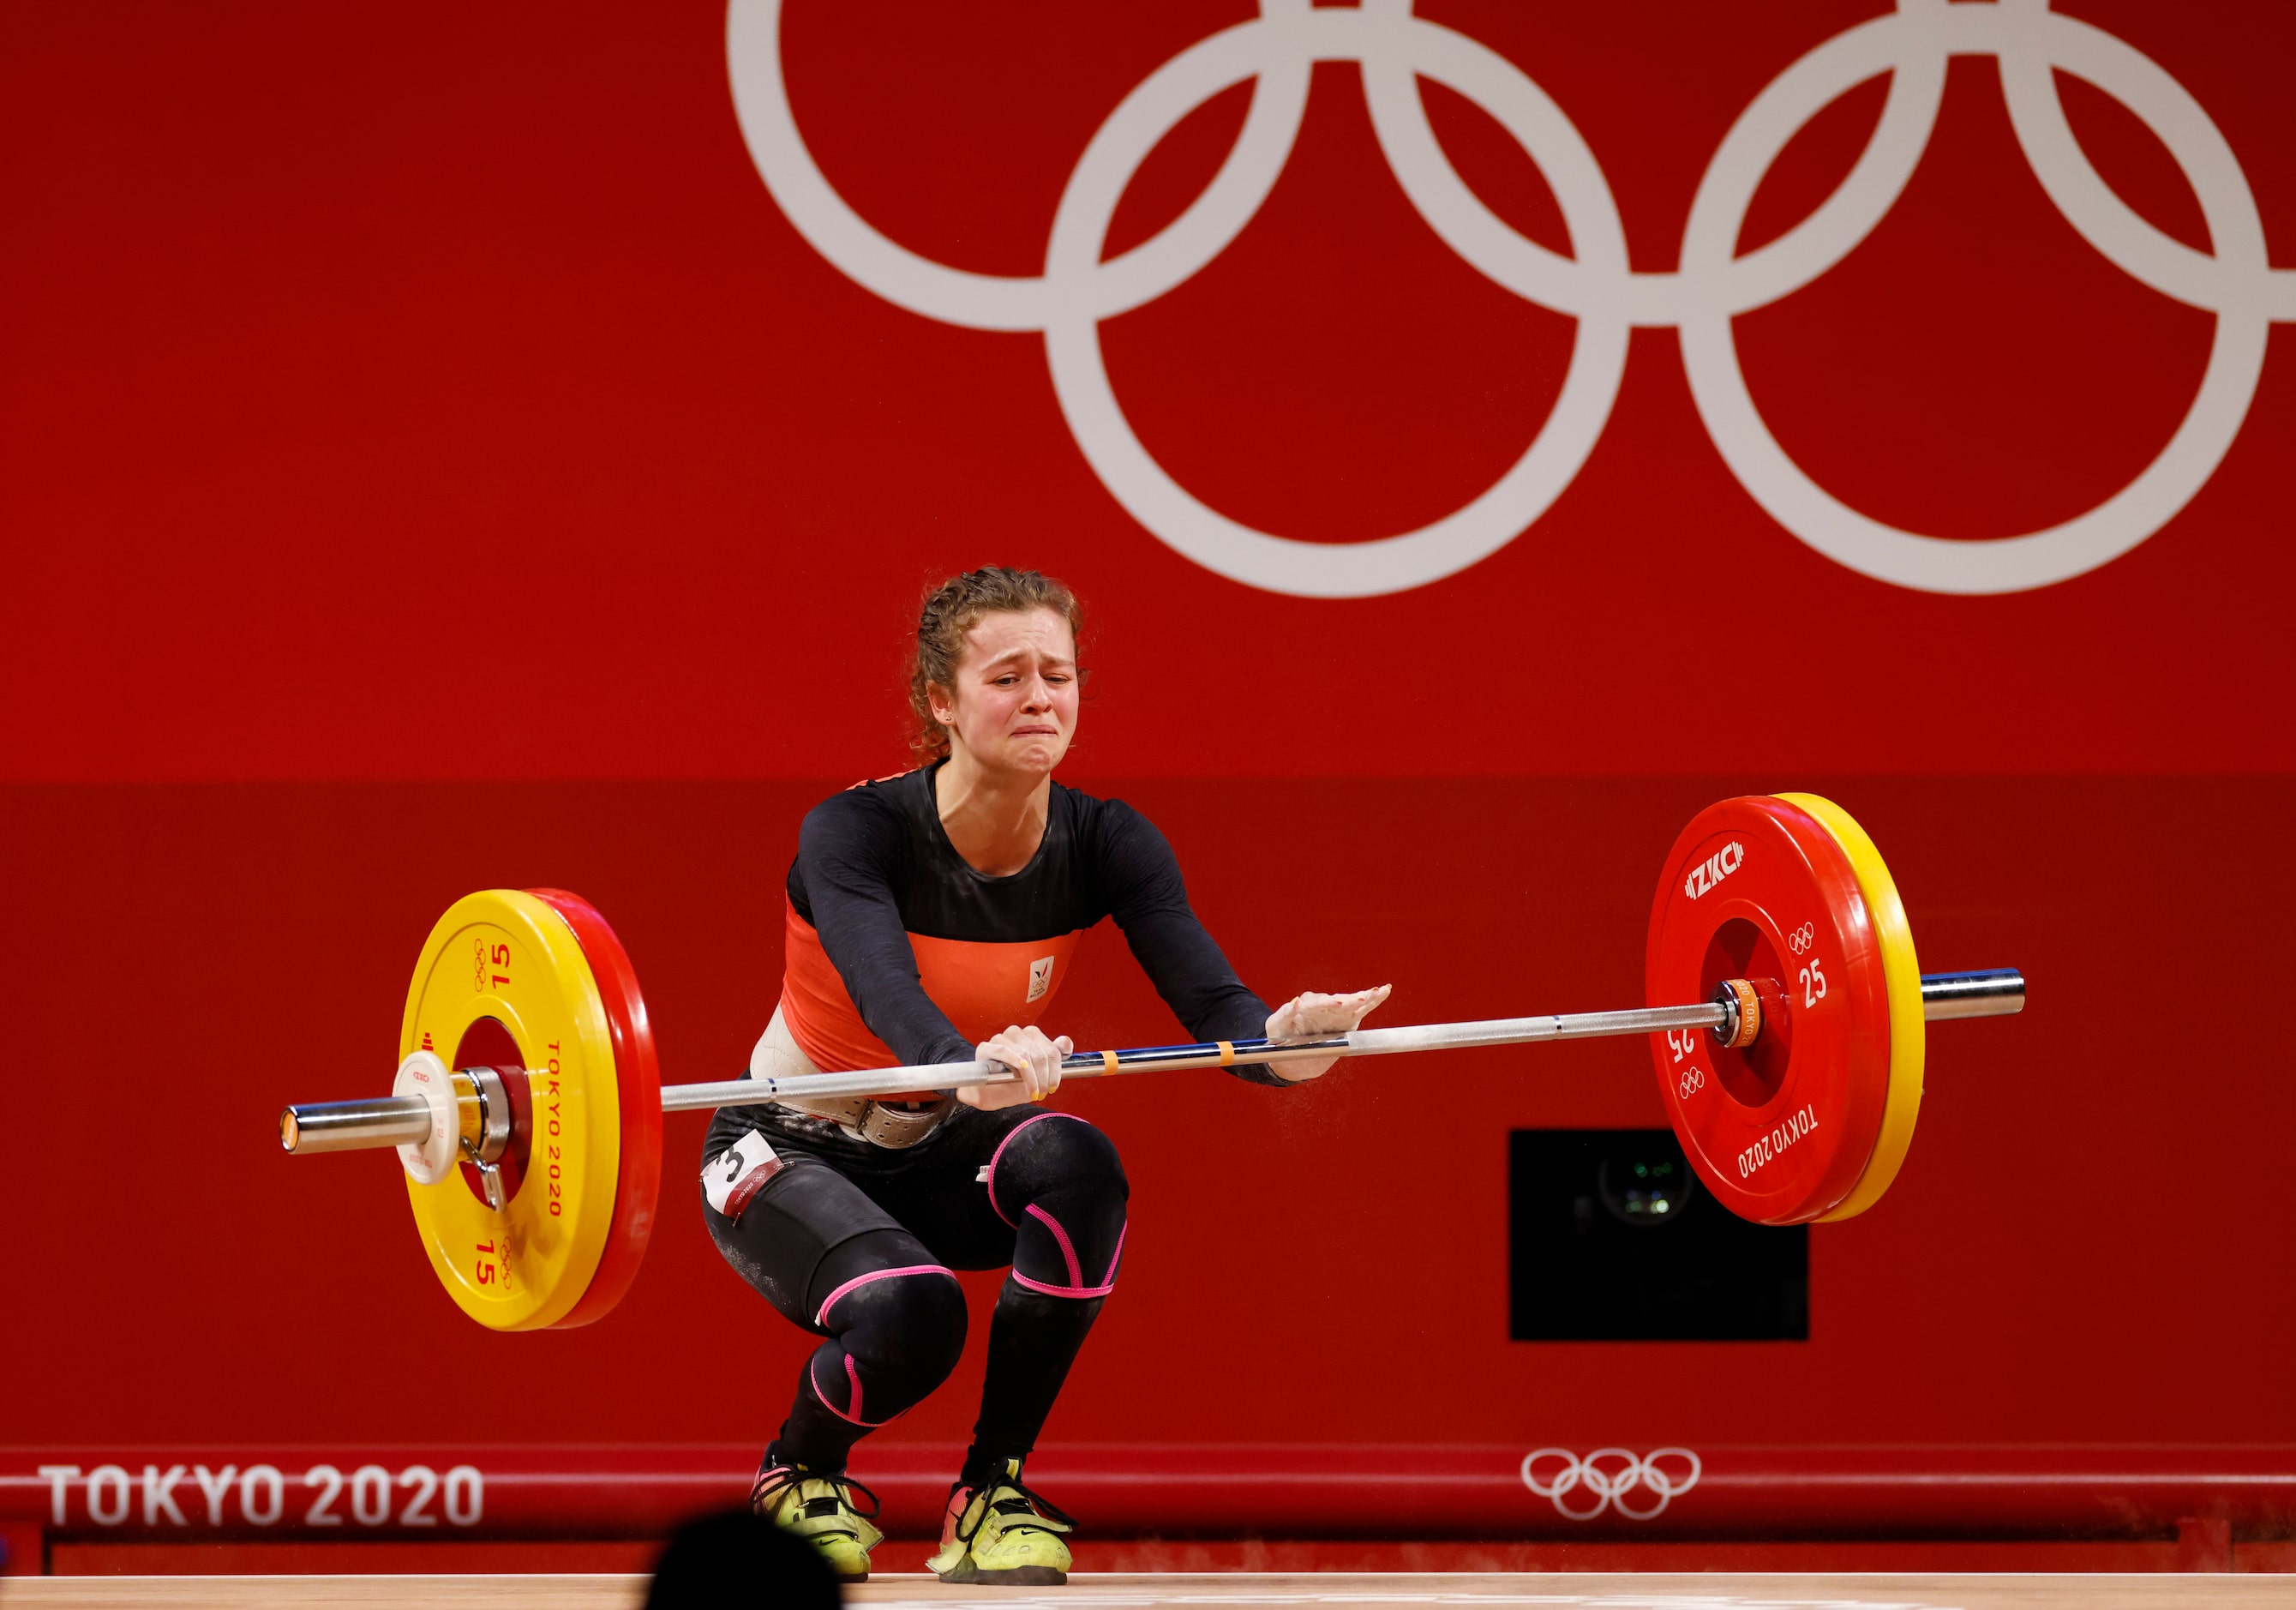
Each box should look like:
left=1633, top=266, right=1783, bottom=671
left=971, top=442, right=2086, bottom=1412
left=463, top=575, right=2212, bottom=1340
left=525, top=889, right=662, bottom=1330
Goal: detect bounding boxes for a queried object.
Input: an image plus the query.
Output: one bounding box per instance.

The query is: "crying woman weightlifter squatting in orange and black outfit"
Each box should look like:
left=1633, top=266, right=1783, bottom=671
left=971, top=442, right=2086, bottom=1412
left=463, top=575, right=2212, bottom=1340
left=703, top=568, right=1387, bottom=1585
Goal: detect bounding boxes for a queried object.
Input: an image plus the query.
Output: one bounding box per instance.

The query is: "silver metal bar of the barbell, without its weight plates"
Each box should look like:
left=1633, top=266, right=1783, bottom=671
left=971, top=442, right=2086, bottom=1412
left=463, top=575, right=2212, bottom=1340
left=280, top=967, right=2025, bottom=1156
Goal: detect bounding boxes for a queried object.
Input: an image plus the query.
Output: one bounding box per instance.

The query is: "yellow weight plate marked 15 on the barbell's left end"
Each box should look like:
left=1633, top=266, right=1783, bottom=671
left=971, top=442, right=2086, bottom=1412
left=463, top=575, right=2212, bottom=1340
left=399, top=889, right=622, bottom=1330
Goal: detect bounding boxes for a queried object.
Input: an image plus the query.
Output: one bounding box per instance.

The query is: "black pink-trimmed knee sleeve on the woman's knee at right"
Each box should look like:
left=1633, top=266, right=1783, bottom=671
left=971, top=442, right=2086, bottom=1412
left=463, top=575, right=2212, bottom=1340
left=987, top=1112, right=1132, bottom=1298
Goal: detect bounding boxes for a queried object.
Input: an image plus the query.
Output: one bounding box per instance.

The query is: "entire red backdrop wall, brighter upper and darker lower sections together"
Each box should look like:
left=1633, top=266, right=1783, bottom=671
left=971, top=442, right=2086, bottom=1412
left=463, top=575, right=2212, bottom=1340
left=0, top=0, right=2296, bottom=1447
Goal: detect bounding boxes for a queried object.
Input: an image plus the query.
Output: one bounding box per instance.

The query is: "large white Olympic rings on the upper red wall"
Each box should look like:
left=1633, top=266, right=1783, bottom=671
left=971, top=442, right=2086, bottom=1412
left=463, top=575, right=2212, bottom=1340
left=726, top=0, right=2296, bottom=598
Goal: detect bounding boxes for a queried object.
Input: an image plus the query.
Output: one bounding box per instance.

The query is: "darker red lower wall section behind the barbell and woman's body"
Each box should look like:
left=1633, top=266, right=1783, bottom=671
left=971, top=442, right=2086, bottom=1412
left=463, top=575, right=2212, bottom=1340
left=0, top=774, right=2296, bottom=1447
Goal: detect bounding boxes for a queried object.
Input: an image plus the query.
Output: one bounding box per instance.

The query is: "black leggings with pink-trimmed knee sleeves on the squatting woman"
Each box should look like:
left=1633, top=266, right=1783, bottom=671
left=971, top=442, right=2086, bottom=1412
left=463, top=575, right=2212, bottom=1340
left=703, top=1107, right=1127, bottom=1475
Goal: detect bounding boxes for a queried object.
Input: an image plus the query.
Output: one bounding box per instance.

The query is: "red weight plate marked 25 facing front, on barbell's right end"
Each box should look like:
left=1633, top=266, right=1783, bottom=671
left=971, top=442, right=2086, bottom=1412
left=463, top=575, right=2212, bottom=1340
left=1646, top=795, right=1890, bottom=1224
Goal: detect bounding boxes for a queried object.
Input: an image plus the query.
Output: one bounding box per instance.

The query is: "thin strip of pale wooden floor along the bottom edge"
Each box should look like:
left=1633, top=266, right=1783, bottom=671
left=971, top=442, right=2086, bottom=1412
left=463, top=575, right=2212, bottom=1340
left=0, top=1571, right=2296, bottom=1610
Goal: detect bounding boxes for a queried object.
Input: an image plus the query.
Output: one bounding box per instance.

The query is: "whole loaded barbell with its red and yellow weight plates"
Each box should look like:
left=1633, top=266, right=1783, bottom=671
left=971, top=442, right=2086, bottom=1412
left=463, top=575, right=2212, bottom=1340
left=280, top=795, right=2025, bottom=1330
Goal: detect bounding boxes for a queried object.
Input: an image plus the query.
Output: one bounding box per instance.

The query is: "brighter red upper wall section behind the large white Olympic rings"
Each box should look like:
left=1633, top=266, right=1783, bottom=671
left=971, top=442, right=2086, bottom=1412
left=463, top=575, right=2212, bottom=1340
left=0, top=0, right=2296, bottom=781
